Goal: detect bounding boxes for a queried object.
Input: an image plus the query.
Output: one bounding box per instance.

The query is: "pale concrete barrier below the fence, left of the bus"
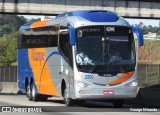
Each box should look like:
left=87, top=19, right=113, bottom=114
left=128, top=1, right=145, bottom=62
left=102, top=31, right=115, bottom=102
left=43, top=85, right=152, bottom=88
left=0, top=82, right=19, bottom=94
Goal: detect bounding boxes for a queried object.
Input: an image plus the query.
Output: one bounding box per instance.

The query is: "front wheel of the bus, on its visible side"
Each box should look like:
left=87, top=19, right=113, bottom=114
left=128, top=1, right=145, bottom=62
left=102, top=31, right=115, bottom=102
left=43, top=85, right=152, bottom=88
left=63, top=86, right=74, bottom=106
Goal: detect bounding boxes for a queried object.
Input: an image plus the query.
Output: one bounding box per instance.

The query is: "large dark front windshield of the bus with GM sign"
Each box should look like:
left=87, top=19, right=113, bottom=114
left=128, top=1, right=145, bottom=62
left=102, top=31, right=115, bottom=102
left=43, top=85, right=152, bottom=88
left=76, top=26, right=136, bottom=74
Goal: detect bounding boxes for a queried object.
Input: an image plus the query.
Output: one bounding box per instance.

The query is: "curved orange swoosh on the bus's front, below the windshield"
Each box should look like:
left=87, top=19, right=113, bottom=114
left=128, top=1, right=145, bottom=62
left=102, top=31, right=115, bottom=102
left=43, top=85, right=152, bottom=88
left=106, top=72, right=134, bottom=85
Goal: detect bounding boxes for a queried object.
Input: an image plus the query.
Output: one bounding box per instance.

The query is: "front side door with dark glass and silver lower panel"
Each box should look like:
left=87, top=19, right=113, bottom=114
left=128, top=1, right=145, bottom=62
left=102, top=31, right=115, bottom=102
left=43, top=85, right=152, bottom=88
left=59, top=27, right=73, bottom=98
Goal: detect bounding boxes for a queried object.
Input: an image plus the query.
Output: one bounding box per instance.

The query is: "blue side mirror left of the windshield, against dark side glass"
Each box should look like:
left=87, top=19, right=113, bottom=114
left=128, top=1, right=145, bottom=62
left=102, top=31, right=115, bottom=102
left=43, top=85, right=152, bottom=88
left=69, top=27, right=76, bottom=46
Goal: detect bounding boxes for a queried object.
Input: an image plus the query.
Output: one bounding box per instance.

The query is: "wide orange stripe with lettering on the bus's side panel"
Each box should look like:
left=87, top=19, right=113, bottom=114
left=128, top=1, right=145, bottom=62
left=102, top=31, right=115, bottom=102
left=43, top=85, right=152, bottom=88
left=28, top=48, right=60, bottom=96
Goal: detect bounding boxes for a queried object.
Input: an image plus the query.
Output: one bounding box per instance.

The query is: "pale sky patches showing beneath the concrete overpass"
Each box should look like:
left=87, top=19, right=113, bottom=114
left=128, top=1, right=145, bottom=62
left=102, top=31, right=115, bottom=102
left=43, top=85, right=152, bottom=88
left=23, top=15, right=160, bottom=27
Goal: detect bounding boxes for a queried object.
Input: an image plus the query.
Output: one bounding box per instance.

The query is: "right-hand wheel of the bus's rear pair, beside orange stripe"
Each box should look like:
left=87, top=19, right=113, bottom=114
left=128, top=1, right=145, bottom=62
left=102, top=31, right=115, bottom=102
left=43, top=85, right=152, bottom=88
left=31, top=82, right=39, bottom=101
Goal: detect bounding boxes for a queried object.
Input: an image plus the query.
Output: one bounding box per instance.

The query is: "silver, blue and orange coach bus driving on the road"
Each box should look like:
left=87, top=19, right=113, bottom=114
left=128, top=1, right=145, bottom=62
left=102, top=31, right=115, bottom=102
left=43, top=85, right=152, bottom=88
left=18, top=10, right=143, bottom=107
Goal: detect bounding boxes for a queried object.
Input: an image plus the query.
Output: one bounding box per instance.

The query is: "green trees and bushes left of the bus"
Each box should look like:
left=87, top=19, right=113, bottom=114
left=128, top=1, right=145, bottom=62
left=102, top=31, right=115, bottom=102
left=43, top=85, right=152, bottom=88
left=0, top=14, right=40, bottom=66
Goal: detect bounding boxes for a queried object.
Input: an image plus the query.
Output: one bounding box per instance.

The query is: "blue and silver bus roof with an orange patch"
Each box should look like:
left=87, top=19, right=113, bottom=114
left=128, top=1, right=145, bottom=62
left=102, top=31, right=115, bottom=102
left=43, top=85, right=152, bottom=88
left=20, top=10, right=126, bottom=30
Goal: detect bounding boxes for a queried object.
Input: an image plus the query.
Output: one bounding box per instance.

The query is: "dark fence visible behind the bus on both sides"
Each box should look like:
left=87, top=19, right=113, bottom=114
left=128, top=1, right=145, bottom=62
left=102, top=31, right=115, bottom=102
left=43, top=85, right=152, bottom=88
left=0, top=64, right=160, bottom=88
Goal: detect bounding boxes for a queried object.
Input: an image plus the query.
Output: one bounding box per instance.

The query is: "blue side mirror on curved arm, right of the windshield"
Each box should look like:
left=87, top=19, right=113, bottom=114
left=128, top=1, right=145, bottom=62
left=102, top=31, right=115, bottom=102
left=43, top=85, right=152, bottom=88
left=132, top=26, right=144, bottom=46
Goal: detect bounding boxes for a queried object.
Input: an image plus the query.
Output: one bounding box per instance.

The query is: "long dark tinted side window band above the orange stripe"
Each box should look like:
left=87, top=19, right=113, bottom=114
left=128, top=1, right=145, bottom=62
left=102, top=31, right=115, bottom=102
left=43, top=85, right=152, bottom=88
left=18, top=27, right=58, bottom=48
